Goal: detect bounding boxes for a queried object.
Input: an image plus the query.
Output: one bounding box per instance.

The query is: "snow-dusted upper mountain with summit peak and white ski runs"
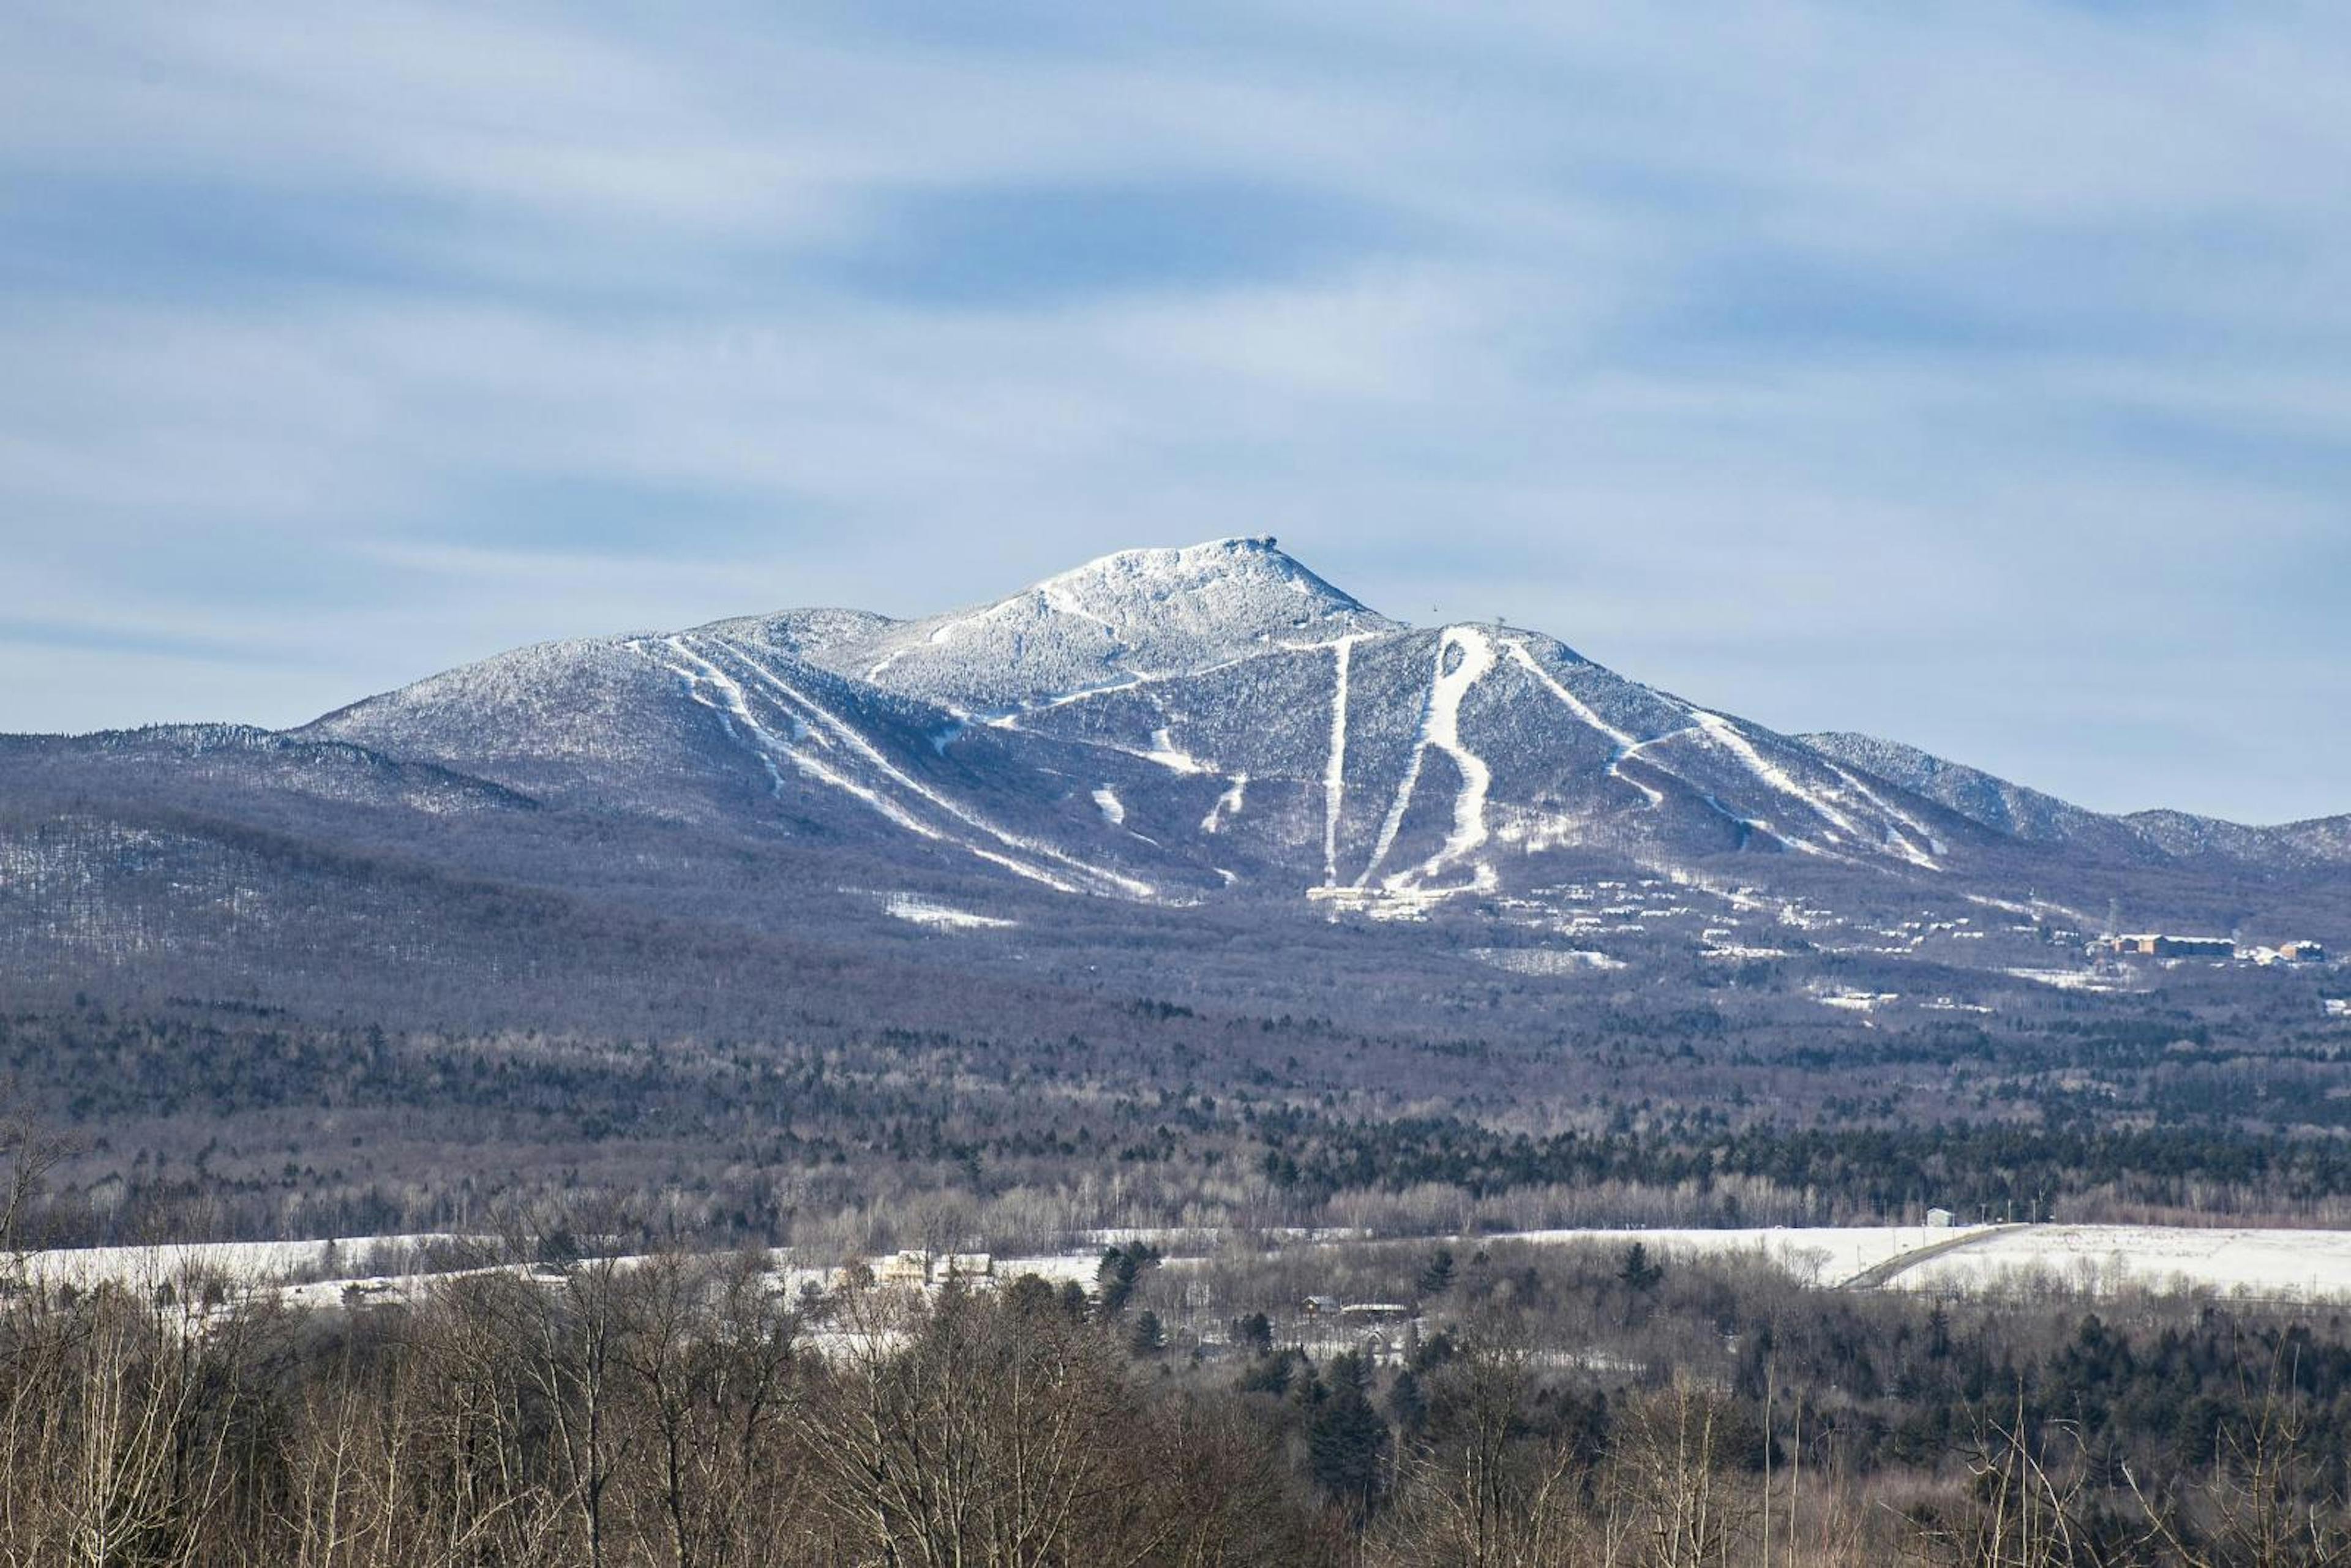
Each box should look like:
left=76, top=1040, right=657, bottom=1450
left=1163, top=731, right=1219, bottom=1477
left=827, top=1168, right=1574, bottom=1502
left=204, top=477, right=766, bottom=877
left=306, top=538, right=1982, bottom=912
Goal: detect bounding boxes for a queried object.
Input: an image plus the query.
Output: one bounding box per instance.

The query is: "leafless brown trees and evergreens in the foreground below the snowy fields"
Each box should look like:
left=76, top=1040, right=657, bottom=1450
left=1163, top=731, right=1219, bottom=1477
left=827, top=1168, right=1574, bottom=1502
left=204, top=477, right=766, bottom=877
left=13, top=1241, right=2351, bottom=1568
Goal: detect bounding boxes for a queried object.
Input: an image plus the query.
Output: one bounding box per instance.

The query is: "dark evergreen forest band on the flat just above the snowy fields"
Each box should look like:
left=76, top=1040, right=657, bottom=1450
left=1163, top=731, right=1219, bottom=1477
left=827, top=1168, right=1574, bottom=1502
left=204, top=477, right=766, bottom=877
left=23, top=1008, right=2351, bottom=1251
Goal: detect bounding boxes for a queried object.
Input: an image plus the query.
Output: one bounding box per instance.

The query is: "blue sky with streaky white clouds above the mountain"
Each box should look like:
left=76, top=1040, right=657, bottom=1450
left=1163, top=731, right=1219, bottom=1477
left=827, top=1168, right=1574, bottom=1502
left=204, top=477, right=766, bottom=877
left=0, top=0, right=2351, bottom=820
